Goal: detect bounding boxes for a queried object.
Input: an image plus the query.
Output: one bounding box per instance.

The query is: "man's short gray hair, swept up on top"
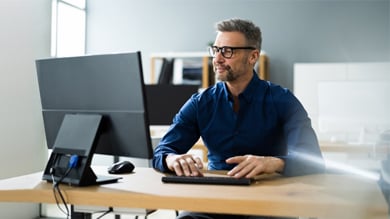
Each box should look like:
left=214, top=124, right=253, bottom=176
left=215, top=18, right=262, bottom=50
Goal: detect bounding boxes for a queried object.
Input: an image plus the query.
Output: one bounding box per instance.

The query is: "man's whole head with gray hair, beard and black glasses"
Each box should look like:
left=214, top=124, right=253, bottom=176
left=210, top=18, right=261, bottom=83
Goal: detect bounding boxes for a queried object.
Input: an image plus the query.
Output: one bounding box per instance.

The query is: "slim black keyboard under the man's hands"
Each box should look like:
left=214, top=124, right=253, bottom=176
left=161, top=175, right=254, bottom=185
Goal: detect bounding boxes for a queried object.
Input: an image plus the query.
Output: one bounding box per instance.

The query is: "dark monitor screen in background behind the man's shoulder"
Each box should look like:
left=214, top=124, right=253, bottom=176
left=146, top=84, right=199, bottom=125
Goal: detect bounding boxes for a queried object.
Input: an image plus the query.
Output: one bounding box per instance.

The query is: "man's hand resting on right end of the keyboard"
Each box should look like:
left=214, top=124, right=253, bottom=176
left=226, top=155, right=284, bottom=178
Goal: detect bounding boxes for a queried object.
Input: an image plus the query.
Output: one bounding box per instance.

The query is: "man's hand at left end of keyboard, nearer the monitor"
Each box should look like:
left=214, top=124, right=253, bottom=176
left=165, top=154, right=203, bottom=176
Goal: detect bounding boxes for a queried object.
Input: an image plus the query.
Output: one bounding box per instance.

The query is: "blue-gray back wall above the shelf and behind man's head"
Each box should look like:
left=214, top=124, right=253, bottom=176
left=87, top=0, right=390, bottom=89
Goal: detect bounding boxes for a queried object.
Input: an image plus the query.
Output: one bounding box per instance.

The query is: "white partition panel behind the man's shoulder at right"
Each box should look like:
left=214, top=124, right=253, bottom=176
left=294, top=62, right=390, bottom=143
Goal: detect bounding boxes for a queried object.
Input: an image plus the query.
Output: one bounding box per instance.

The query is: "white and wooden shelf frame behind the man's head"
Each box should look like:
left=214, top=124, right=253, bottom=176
left=150, top=52, right=269, bottom=88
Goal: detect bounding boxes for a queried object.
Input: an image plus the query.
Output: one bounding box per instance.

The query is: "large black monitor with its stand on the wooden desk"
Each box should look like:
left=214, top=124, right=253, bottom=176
left=36, top=52, right=153, bottom=186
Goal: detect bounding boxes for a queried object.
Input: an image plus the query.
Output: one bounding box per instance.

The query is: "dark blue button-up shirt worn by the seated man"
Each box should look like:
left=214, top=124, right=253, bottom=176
left=153, top=72, right=324, bottom=175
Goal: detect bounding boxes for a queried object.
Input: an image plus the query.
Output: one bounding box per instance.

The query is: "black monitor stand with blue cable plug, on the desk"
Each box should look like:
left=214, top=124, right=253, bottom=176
left=42, top=114, right=121, bottom=186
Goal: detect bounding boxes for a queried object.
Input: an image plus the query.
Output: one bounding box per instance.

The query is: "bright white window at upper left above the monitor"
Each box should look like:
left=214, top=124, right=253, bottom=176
left=51, top=0, right=86, bottom=57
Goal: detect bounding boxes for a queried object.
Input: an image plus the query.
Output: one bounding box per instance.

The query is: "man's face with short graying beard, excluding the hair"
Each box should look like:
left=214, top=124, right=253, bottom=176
left=213, top=32, right=252, bottom=82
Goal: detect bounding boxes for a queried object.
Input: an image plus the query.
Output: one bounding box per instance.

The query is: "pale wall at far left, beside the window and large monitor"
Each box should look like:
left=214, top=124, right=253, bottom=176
left=0, top=0, right=51, bottom=219
